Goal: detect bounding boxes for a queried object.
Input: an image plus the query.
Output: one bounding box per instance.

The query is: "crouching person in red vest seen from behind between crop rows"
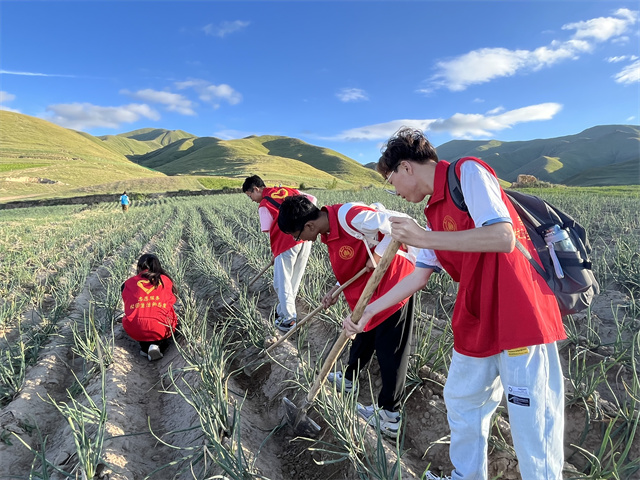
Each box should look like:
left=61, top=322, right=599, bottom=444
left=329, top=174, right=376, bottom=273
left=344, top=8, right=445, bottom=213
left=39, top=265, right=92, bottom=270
left=122, top=253, right=178, bottom=361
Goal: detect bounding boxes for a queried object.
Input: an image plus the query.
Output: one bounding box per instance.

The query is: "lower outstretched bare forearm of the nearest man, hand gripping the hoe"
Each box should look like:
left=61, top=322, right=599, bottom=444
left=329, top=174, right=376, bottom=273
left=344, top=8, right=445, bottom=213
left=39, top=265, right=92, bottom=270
left=342, top=267, right=435, bottom=335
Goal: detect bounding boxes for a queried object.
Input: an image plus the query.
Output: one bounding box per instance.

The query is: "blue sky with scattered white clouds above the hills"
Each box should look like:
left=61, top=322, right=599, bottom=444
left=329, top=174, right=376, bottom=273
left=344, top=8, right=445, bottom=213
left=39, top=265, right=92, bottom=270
left=0, top=0, right=640, bottom=163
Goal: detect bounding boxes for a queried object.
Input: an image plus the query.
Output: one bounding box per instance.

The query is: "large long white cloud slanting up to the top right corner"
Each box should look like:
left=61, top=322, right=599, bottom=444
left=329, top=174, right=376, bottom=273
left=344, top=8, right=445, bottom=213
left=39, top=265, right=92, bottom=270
left=428, top=9, right=638, bottom=93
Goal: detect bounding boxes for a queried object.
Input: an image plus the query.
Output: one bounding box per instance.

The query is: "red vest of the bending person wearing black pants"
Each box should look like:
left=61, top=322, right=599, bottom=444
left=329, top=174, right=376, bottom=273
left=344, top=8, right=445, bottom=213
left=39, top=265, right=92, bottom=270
left=321, top=204, right=414, bottom=332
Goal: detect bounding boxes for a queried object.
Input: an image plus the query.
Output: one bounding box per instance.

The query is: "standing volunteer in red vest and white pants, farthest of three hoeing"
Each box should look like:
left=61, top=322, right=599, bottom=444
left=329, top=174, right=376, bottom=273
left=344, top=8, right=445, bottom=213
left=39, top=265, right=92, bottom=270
left=242, top=175, right=317, bottom=332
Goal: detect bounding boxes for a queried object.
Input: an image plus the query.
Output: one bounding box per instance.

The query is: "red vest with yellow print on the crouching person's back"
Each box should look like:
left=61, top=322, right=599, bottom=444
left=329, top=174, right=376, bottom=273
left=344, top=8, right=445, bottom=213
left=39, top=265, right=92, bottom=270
left=122, top=275, right=178, bottom=342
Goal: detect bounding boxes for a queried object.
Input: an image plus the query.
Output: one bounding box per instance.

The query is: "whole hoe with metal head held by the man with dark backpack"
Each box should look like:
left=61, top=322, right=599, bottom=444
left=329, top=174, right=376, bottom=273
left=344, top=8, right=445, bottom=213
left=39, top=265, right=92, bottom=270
left=282, top=240, right=400, bottom=437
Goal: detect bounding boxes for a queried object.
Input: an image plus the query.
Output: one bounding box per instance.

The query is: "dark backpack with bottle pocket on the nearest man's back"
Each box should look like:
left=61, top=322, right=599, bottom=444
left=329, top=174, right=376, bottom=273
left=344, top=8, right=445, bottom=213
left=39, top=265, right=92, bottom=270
left=447, top=160, right=600, bottom=316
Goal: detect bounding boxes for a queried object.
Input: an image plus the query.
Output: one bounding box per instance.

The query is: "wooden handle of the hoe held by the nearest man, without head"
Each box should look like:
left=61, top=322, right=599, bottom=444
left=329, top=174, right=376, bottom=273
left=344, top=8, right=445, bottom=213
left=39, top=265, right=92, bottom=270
left=306, top=240, right=400, bottom=404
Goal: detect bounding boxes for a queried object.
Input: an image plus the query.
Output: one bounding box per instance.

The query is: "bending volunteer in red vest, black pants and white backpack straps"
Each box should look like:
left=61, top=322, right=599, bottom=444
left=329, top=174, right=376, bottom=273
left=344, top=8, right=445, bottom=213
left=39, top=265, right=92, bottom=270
left=278, top=197, right=415, bottom=438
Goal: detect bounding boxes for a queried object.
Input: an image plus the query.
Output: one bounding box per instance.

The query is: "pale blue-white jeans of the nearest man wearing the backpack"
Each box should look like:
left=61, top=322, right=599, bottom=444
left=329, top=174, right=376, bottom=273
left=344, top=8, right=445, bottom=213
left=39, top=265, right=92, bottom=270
left=444, top=343, right=564, bottom=480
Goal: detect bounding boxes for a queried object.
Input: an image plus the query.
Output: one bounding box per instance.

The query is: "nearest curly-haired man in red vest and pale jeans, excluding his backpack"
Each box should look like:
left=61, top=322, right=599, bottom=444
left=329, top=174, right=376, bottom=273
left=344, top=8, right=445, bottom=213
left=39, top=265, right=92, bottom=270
left=343, top=128, right=566, bottom=480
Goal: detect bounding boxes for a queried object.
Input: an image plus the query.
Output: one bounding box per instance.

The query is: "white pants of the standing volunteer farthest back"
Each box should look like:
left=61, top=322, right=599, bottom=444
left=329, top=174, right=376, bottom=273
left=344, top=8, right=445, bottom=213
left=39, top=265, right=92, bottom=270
left=273, top=242, right=311, bottom=320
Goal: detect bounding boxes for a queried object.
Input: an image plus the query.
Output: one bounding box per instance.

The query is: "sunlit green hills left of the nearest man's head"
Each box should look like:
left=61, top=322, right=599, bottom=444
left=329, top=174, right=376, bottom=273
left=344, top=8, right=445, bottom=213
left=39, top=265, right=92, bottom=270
left=0, top=111, right=382, bottom=200
